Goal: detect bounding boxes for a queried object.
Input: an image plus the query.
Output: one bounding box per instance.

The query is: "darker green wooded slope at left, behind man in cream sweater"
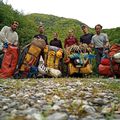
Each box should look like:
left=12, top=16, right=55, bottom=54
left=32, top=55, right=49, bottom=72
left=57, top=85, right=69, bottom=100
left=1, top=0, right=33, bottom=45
left=0, top=2, right=37, bottom=46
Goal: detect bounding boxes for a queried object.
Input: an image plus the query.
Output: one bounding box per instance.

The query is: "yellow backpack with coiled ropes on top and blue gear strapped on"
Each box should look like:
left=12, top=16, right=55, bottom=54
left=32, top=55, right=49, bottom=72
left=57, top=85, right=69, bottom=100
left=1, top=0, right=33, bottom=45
left=66, top=44, right=95, bottom=75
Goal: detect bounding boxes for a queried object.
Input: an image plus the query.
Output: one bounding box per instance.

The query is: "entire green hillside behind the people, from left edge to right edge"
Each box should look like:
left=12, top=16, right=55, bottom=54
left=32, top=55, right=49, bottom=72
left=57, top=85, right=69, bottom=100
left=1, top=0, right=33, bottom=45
left=0, top=1, right=120, bottom=46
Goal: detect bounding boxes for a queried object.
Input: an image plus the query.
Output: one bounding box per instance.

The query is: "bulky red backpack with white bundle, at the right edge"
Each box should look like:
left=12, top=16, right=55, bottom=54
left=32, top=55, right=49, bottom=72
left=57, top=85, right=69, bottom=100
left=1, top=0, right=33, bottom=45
left=98, top=44, right=120, bottom=76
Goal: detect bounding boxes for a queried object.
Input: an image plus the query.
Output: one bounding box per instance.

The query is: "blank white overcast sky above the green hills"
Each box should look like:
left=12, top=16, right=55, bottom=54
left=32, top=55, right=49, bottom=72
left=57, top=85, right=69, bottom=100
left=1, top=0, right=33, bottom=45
left=3, top=0, right=120, bottom=28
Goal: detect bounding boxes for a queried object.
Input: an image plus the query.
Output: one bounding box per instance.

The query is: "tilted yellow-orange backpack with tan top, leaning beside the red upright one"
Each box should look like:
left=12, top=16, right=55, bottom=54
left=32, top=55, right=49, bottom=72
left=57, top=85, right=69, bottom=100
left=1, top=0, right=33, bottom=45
left=14, top=38, right=46, bottom=78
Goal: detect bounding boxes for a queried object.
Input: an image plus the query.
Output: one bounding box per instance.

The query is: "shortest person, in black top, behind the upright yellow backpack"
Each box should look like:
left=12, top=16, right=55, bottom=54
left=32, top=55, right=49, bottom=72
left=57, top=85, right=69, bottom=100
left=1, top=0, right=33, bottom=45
left=50, top=32, right=62, bottom=48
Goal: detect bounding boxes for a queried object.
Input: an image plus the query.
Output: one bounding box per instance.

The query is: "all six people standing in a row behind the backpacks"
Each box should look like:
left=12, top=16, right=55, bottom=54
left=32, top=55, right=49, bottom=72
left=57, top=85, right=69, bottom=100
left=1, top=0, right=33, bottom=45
left=0, top=21, right=109, bottom=75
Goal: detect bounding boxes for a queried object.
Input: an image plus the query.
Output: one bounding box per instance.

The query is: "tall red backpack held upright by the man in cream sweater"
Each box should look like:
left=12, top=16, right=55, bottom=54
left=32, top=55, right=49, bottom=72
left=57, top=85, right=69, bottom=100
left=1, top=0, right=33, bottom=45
left=0, top=45, right=18, bottom=78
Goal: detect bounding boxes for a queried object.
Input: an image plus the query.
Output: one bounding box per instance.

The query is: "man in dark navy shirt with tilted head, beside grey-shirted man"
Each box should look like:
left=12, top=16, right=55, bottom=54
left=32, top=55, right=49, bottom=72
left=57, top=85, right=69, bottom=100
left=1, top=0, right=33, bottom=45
left=80, top=25, right=94, bottom=45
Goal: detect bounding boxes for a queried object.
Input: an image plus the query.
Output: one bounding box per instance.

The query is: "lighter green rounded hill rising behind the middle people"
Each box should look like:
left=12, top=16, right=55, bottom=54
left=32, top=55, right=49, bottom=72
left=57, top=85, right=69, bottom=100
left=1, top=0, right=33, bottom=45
left=26, top=13, right=87, bottom=42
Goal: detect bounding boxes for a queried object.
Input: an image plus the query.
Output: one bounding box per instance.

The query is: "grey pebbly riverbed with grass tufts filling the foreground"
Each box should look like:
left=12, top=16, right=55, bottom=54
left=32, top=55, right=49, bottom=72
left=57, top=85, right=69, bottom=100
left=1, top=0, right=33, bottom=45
left=0, top=78, right=120, bottom=120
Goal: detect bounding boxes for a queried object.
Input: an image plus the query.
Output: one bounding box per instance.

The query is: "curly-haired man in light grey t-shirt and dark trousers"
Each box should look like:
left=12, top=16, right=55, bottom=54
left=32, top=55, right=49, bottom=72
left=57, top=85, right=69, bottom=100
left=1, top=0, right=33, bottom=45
left=91, top=24, right=109, bottom=72
